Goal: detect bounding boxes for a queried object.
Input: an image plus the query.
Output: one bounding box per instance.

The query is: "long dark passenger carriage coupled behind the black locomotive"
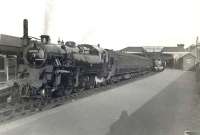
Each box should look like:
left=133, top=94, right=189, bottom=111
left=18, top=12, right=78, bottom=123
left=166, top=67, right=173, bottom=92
left=104, top=51, right=153, bottom=82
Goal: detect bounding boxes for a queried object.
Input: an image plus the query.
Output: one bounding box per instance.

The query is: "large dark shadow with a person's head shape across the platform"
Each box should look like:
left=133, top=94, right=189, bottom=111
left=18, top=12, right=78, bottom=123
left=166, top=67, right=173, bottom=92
left=106, top=71, right=200, bottom=135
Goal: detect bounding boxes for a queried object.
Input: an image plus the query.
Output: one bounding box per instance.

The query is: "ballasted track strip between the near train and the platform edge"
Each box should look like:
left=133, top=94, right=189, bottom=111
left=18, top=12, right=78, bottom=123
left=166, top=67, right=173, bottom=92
left=0, top=72, right=155, bottom=124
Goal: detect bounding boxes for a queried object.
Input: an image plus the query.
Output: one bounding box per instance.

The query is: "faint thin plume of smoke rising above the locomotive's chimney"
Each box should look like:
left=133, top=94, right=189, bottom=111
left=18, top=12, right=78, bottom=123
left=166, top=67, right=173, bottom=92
left=44, top=0, right=54, bottom=34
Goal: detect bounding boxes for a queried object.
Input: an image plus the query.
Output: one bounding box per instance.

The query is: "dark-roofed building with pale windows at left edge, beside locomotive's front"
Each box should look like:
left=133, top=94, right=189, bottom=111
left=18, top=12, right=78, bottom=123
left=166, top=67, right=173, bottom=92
left=0, top=34, right=22, bottom=83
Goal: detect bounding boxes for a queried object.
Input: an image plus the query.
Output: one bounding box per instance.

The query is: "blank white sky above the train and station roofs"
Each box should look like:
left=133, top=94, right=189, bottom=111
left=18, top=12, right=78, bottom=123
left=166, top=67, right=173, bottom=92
left=0, top=0, right=200, bottom=50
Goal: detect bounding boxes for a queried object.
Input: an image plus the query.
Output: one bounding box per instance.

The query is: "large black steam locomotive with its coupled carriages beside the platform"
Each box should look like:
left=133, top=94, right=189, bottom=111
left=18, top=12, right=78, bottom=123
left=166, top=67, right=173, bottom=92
left=0, top=20, right=162, bottom=99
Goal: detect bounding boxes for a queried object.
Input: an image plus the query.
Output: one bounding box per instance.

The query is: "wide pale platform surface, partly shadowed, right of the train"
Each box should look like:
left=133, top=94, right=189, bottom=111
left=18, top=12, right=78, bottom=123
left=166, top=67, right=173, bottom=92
left=0, top=69, right=200, bottom=135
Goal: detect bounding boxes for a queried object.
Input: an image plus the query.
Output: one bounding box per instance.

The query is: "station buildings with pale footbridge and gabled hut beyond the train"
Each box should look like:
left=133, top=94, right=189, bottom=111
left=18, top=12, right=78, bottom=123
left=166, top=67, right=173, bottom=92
left=120, top=44, right=197, bottom=70
